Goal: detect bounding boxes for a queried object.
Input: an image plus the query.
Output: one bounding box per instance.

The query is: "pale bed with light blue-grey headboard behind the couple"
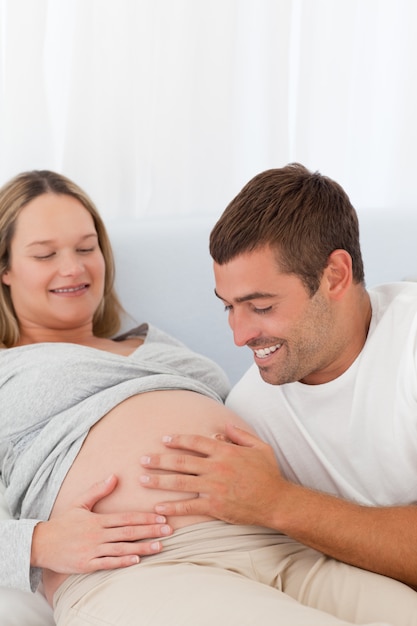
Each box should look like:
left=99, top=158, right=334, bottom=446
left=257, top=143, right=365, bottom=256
left=0, top=211, right=417, bottom=626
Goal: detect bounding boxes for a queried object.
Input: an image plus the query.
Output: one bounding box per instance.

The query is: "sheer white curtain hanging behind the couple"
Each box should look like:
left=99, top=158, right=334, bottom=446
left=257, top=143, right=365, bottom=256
left=0, top=0, right=417, bottom=220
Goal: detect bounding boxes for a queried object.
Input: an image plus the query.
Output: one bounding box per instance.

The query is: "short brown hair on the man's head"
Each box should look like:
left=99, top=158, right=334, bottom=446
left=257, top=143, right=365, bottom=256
left=210, top=163, right=364, bottom=295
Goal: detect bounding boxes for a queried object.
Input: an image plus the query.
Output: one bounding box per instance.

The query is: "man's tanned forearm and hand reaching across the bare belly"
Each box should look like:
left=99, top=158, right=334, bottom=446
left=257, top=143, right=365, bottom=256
left=141, top=426, right=417, bottom=587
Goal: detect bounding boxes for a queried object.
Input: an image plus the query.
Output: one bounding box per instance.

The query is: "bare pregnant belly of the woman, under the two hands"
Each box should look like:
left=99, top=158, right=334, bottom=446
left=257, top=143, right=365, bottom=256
left=44, top=390, right=251, bottom=598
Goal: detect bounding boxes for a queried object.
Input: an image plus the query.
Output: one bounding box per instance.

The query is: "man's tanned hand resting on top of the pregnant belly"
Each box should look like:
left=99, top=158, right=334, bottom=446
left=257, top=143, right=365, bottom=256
left=140, top=425, right=289, bottom=528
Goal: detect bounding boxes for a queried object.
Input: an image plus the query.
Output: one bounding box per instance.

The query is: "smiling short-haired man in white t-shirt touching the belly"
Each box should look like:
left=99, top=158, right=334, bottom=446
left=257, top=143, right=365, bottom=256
left=140, top=164, right=417, bottom=623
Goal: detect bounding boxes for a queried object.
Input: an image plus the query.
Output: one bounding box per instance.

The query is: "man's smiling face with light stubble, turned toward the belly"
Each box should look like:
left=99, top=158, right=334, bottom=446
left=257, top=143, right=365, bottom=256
left=214, top=246, right=344, bottom=385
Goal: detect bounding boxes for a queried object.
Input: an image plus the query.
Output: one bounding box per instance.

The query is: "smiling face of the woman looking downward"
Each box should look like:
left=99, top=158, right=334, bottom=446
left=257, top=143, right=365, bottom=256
left=2, top=193, right=105, bottom=337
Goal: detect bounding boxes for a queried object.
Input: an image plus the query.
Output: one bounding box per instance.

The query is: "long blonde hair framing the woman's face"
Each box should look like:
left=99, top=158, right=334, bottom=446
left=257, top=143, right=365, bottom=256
left=0, top=170, right=124, bottom=348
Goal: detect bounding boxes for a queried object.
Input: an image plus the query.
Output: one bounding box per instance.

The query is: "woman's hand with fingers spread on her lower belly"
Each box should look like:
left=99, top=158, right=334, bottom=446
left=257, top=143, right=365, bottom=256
left=31, top=476, right=172, bottom=574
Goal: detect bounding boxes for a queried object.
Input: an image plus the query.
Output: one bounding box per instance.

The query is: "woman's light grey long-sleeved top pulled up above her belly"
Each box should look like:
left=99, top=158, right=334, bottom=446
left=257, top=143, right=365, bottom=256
left=0, top=324, right=229, bottom=591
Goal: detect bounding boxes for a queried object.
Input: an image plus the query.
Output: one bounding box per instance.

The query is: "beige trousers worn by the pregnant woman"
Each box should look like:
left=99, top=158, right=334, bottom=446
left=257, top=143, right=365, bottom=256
left=54, top=522, right=417, bottom=626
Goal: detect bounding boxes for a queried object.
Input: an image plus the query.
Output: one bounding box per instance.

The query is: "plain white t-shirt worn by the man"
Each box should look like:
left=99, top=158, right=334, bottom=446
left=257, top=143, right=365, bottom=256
left=226, top=282, right=417, bottom=506
